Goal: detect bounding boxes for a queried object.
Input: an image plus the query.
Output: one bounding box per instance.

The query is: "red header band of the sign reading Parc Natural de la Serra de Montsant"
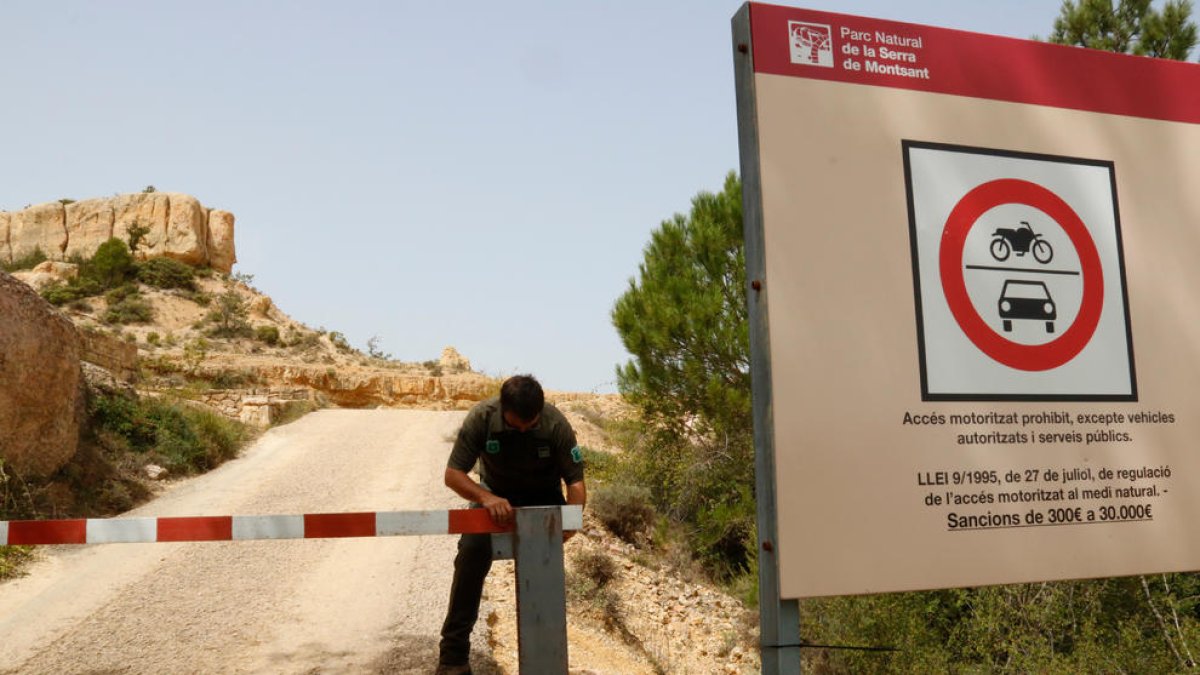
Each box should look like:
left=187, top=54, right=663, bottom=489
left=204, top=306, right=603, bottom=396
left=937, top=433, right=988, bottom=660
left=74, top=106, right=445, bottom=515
left=750, top=4, right=1200, bottom=124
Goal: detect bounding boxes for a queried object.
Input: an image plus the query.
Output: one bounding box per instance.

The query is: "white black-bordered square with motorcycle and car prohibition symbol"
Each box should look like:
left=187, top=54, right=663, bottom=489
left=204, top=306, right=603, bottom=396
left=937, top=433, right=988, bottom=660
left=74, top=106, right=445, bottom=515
left=902, top=141, right=1138, bottom=401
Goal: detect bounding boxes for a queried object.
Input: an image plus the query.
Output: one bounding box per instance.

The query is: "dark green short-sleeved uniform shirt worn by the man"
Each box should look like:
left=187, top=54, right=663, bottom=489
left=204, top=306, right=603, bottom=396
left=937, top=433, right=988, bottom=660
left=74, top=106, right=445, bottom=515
left=446, top=396, right=583, bottom=500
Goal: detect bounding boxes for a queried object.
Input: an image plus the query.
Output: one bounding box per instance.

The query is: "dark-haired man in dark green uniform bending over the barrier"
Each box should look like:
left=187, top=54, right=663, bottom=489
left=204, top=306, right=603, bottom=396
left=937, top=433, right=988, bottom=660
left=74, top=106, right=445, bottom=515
left=438, top=375, right=587, bottom=675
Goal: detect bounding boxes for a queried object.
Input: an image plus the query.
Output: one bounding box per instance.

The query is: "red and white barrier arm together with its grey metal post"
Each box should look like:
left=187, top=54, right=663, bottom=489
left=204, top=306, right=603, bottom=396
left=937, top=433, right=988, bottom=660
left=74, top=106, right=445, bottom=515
left=0, top=506, right=583, bottom=675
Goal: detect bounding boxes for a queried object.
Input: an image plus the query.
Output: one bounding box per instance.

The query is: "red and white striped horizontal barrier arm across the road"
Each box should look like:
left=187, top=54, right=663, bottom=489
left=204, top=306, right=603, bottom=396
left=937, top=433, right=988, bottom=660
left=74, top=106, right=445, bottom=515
left=0, top=506, right=583, bottom=546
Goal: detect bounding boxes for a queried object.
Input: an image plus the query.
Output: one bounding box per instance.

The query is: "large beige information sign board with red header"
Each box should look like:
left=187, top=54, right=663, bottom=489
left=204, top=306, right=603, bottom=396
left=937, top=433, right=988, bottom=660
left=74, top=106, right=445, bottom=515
left=738, top=4, right=1200, bottom=598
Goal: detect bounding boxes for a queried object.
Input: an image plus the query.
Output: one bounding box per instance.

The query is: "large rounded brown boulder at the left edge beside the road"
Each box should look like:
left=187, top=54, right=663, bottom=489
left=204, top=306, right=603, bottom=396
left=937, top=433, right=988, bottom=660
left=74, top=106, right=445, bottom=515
left=0, top=271, right=84, bottom=476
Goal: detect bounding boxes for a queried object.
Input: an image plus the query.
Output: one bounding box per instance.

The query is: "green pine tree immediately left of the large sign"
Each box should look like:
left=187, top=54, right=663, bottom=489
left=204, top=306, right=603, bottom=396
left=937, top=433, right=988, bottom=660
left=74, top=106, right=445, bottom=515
left=612, top=173, right=755, bottom=574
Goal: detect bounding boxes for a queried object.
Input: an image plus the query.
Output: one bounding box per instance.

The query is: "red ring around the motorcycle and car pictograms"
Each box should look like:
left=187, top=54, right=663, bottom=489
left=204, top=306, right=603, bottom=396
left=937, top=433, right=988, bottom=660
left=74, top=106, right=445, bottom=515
left=938, top=178, right=1104, bottom=371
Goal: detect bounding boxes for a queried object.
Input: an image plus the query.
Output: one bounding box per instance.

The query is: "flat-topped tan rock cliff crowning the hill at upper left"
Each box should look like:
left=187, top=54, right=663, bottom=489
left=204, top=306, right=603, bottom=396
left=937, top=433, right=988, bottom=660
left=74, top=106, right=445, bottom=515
left=0, top=192, right=238, bottom=274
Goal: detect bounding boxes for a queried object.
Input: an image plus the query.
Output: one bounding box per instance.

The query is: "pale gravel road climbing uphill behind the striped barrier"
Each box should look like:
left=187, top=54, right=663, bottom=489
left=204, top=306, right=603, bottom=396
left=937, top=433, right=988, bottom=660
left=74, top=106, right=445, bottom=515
left=0, top=410, right=494, bottom=674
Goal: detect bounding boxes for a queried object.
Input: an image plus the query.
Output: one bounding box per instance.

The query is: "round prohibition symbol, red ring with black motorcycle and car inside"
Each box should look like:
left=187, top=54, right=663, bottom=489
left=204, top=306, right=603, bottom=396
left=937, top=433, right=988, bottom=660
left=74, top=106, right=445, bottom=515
left=938, top=179, right=1104, bottom=371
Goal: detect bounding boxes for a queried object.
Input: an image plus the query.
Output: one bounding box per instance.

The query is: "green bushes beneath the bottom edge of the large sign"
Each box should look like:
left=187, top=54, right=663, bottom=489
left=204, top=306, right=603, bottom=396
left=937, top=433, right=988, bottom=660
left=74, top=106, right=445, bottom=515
left=800, top=573, right=1200, bottom=674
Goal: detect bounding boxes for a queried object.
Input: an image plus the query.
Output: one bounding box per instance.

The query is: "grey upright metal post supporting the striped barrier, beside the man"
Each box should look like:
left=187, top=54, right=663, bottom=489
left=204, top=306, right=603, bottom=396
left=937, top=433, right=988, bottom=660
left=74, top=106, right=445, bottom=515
left=512, top=507, right=568, bottom=675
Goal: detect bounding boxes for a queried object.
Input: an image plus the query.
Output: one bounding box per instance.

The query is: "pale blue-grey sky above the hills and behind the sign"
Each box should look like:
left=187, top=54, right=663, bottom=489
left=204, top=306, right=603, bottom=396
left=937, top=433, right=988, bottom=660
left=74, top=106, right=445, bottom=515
left=0, top=0, right=1123, bottom=392
